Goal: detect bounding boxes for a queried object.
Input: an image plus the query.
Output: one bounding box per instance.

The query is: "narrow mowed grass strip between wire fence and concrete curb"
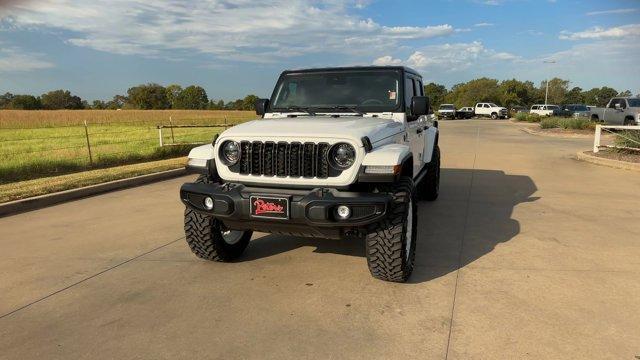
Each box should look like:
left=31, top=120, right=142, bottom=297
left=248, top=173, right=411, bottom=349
left=0, top=157, right=187, bottom=203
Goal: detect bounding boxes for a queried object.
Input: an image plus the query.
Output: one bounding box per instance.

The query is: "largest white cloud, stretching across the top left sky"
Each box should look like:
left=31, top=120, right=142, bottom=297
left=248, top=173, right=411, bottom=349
left=0, top=0, right=456, bottom=62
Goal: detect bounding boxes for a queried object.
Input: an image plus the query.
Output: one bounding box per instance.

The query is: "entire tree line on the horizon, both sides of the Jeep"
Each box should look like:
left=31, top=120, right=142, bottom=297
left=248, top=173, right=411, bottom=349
left=0, top=78, right=631, bottom=110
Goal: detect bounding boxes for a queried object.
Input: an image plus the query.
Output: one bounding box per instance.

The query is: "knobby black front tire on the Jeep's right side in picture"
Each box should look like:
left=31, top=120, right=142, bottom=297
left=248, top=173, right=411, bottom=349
left=366, top=176, right=418, bottom=282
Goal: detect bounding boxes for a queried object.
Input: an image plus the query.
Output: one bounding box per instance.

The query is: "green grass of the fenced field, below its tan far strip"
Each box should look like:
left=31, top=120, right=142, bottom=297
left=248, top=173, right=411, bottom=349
left=0, top=122, right=232, bottom=184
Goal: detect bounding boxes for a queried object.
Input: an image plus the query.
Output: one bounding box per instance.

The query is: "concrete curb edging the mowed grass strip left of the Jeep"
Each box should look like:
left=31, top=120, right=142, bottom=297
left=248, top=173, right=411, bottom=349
left=0, top=168, right=188, bottom=217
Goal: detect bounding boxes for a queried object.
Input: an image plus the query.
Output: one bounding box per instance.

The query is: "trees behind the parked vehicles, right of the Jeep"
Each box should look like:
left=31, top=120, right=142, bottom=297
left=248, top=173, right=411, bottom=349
left=424, top=78, right=632, bottom=108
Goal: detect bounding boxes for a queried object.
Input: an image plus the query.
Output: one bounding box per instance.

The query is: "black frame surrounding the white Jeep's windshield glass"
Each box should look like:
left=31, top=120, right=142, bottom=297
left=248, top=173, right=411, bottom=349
left=268, top=68, right=406, bottom=114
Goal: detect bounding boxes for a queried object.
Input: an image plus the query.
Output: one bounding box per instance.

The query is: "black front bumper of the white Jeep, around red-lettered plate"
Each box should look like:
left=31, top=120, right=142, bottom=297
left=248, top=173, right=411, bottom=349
left=180, top=183, right=392, bottom=238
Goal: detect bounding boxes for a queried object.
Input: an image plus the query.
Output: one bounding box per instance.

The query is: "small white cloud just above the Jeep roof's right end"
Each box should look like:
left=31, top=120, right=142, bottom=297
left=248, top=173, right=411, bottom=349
left=374, top=41, right=520, bottom=72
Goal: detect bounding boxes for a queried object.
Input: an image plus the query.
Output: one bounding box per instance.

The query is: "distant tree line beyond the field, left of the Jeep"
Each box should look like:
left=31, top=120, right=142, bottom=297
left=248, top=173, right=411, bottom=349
left=0, top=83, right=258, bottom=110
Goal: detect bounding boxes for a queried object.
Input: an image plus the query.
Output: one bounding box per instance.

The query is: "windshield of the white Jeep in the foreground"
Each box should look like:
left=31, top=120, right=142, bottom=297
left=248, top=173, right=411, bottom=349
left=271, top=70, right=402, bottom=112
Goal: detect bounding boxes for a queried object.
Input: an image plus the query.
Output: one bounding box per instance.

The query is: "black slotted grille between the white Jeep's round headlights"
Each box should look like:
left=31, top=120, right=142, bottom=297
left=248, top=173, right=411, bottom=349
left=231, top=141, right=339, bottom=178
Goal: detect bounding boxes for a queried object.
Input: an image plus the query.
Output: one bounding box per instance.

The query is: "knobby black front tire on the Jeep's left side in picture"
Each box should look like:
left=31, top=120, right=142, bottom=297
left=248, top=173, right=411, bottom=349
left=184, top=175, right=252, bottom=262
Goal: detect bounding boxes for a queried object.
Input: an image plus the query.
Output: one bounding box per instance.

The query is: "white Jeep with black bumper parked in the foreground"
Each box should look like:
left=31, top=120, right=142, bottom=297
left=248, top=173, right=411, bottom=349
left=180, top=67, right=440, bottom=282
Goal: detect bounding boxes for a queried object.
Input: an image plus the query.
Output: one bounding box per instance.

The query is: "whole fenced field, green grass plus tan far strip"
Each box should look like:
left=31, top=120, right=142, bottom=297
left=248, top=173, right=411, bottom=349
left=0, top=110, right=255, bottom=184
